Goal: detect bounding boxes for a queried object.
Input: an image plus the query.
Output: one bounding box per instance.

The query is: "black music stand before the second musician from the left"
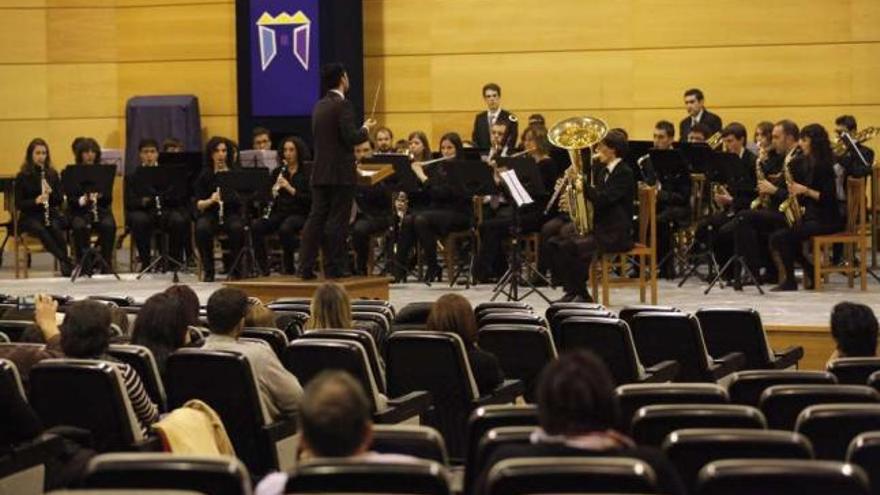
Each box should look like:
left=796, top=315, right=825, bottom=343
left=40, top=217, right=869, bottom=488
left=61, top=165, right=121, bottom=282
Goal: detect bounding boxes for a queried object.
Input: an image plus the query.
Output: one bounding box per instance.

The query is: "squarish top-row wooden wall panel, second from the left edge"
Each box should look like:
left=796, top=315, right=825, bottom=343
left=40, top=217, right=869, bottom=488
left=46, top=8, right=117, bottom=63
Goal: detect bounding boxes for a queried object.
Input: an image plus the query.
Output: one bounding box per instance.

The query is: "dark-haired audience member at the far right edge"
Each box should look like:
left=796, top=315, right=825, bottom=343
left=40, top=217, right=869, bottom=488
left=828, top=302, right=877, bottom=363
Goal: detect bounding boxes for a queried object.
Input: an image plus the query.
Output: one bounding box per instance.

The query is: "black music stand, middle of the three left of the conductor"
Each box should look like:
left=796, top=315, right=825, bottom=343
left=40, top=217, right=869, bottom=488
left=133, top=164, right=188, bottom=284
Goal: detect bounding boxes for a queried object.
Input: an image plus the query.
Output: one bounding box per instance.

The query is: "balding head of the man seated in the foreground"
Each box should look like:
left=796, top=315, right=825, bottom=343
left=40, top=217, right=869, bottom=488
left=300, top=371, right=372, bottom=457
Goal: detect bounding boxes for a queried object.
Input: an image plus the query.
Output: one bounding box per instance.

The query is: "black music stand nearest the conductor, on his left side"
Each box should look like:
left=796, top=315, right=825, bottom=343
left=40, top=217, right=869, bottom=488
left=217, top=168, right=272, bottom=280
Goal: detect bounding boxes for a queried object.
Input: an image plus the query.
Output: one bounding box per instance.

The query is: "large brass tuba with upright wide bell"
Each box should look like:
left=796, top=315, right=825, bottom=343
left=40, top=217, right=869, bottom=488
left=547, top=117, right=608, bottom=236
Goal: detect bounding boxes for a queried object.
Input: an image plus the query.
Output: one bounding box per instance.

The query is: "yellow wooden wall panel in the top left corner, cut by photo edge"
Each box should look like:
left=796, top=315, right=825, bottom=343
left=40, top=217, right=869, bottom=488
left=0, top=8, right=46, bottom=64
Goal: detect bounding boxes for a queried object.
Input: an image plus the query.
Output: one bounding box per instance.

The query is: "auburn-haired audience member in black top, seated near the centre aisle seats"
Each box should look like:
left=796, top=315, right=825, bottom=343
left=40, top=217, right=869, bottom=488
left=426, top=294, right=504, bottom=395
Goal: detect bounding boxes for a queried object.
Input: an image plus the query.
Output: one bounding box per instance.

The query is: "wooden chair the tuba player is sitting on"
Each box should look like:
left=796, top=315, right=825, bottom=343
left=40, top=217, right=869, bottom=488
left=590, top=186, right=657, bottom=306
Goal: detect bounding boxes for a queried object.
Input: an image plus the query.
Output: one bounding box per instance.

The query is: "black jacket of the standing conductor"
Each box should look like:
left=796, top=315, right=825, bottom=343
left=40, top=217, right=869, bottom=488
left=311, top=91, right=370, bottom=186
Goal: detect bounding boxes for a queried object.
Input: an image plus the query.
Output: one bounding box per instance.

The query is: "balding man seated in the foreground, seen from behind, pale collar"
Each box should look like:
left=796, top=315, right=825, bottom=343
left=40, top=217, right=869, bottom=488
left=256, top=371, right=415, bottom=495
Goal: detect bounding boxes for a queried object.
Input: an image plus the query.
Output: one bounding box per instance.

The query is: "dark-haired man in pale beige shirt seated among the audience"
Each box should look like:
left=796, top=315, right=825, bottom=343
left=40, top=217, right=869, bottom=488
left=203, top=288, right=302, bottom=420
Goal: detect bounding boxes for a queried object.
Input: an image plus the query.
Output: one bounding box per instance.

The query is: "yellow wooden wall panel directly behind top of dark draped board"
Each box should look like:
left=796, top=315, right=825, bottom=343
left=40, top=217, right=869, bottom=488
left=117, top=60, right=238, bottom=115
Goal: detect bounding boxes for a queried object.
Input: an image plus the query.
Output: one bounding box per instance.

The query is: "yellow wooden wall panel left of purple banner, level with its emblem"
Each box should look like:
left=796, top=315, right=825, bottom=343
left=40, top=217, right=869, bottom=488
left=116, top=3, right=235, bottom=61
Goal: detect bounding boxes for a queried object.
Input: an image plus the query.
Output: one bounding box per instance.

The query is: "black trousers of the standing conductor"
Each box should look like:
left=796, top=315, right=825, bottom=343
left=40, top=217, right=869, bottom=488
left=299, top=185, right=355, bottom=277
